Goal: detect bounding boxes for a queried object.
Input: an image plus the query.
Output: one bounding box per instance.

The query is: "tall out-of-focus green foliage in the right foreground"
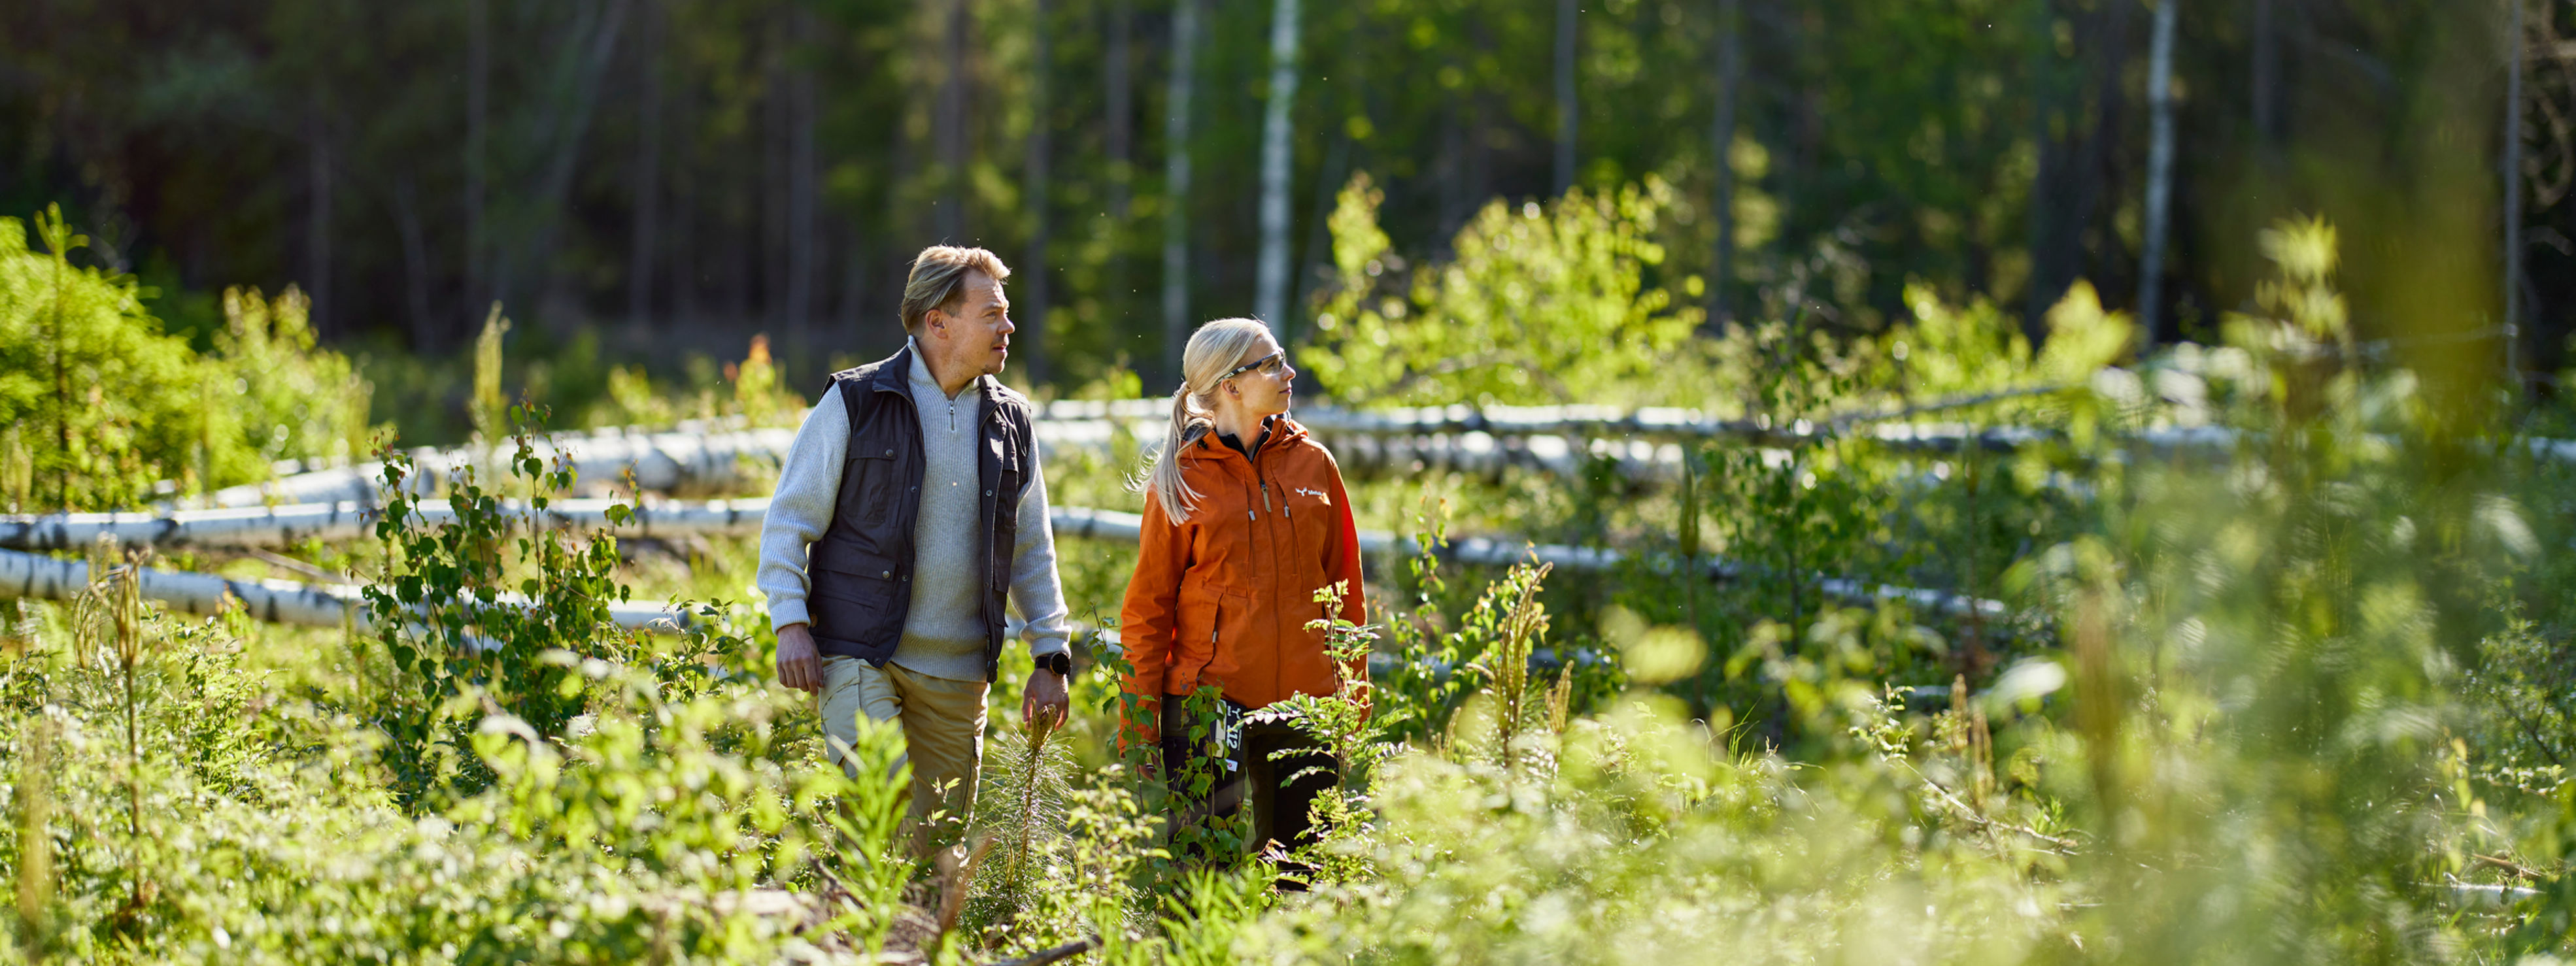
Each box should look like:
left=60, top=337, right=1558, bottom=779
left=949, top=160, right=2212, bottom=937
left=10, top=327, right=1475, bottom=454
left=2017, top=215, right=2527, bottom=961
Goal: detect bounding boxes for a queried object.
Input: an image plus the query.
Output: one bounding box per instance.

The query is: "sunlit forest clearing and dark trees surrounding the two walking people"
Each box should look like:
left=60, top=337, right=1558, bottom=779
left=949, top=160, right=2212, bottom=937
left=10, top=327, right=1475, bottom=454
left=0, top=0, right=2576, bottom=963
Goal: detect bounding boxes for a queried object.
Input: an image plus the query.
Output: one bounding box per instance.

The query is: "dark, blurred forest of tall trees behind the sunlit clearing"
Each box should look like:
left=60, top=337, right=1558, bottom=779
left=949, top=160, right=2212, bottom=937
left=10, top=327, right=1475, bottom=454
left=0, top=0, right=2576, bottom=412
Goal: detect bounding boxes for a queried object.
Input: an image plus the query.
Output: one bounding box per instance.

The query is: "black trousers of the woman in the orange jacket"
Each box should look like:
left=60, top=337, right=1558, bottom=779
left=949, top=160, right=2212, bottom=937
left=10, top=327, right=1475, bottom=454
left=1162, top=698, right=1342, bottom=853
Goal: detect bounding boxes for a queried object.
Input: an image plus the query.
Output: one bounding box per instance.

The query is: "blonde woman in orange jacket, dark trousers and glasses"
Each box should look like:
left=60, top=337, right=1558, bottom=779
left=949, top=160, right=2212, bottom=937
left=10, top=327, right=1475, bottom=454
left=1118, top=320, right=1368, bottom=871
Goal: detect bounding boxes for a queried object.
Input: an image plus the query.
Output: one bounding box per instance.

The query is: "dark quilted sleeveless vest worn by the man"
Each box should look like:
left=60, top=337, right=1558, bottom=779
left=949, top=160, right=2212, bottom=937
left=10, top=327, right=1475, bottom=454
left=806, top=345, right=1036, bottom=680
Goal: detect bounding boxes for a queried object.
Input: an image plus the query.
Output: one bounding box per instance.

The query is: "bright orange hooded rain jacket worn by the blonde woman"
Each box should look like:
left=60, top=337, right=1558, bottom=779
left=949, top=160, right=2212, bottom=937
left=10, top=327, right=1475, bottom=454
left=1118, top=415, right=1368, bottom=742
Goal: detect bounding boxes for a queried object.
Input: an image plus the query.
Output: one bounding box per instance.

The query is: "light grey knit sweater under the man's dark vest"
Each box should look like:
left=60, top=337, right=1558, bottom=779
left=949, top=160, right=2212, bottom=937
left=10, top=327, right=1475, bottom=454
left=757, top=348, right=1066, bottom=680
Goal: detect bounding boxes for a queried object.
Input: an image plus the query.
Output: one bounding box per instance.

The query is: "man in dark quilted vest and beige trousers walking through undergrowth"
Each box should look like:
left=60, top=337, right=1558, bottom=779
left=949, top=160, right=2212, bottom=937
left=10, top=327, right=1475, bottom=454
left=757, top=244, right=1069, bottom=850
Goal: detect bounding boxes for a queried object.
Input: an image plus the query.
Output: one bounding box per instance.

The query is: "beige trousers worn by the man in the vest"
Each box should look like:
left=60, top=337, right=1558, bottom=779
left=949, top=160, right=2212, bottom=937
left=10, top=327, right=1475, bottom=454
left=814, top=657, right=989, bottom=856
